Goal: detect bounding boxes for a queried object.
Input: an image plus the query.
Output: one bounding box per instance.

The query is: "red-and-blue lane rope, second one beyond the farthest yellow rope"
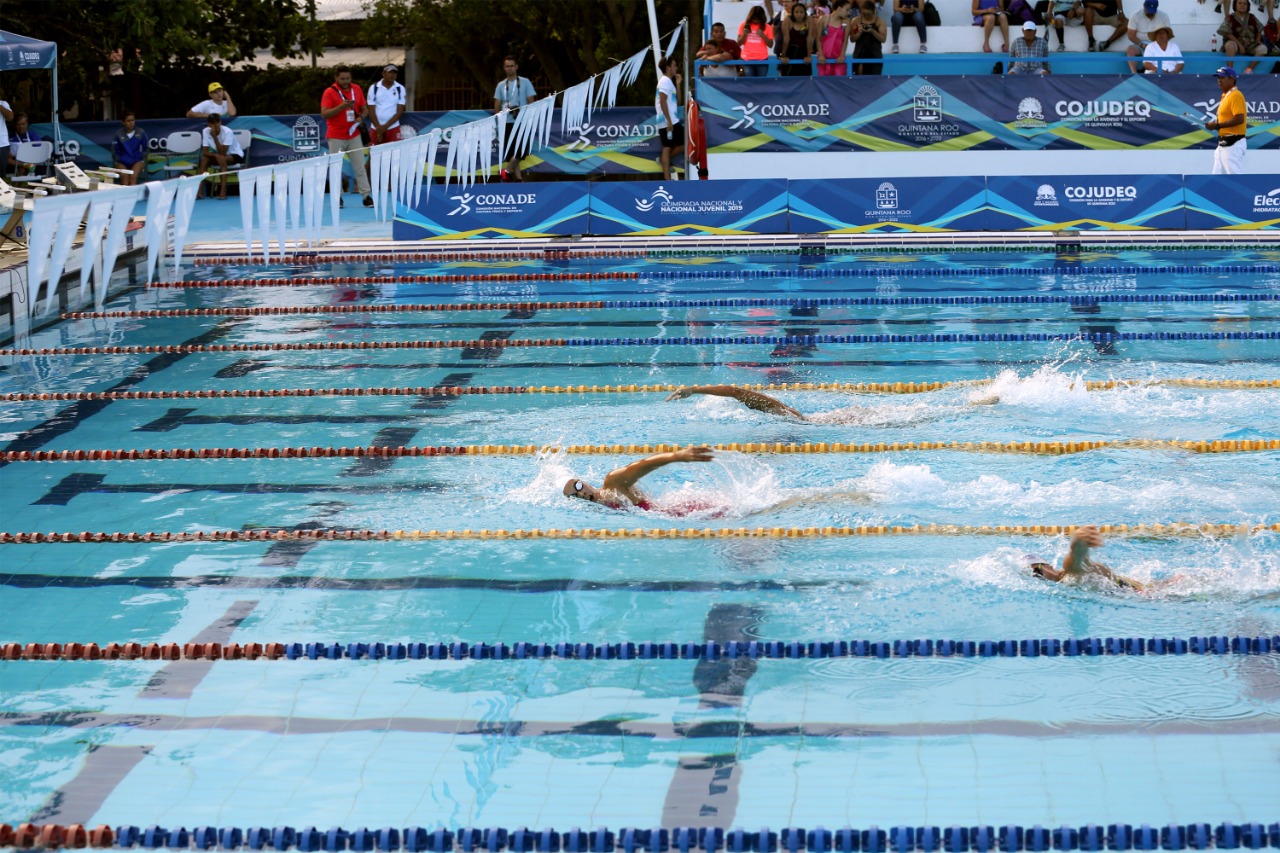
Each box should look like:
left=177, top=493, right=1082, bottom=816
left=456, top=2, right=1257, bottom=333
left=59, top=293, right=1280, bottom=320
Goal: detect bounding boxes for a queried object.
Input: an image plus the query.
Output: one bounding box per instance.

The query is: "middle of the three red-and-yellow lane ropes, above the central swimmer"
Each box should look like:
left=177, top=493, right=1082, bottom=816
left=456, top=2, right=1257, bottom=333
left=0, top=438, right=1280, bottom=462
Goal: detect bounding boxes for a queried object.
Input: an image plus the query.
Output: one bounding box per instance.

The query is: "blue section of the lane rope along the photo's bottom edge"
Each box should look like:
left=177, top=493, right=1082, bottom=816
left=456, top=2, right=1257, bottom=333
left=107, top=822, right=1280, bottom=853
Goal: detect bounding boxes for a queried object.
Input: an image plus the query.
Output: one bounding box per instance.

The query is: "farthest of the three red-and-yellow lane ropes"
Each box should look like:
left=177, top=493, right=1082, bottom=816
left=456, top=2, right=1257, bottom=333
left=10, top=375, right=1280, bottom=402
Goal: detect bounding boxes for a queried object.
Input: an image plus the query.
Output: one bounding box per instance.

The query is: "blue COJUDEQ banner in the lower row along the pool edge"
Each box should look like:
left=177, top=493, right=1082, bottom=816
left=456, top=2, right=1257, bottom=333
left=987, top=174, right=1185, bottom=231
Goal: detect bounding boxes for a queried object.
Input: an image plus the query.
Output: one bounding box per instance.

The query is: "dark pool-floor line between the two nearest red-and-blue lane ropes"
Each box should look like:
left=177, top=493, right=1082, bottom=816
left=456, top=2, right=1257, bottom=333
left=0, top=712, right=1280, bottom=740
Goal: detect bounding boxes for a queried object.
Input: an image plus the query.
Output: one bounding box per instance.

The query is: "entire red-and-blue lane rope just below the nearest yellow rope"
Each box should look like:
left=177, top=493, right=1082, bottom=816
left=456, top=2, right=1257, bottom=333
left=0, top=635, right=1280, bottom=661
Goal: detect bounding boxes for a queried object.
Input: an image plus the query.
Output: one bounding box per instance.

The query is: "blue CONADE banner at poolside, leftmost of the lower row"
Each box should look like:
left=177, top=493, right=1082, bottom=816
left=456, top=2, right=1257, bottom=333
left=392, top=182, right=588, bottom=240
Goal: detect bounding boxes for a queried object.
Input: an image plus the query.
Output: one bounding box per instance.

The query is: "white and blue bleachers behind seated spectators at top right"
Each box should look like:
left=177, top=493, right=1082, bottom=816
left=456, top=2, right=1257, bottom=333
left=711, top=0, right=1239, bottom=74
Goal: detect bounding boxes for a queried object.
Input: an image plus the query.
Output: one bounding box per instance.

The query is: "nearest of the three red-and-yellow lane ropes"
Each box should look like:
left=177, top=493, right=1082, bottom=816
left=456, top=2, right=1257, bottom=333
left=0, top=521, right=1280, bottom=546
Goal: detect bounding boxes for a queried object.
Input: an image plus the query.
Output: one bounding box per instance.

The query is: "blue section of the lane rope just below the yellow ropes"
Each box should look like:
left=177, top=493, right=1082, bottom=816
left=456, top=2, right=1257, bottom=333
left=275, top=635, right=1280, bottom=661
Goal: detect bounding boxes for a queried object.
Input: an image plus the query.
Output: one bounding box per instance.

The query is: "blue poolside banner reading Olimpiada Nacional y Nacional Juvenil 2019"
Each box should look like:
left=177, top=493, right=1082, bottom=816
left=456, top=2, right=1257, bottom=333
left=590, top=179, right=787, bottom=237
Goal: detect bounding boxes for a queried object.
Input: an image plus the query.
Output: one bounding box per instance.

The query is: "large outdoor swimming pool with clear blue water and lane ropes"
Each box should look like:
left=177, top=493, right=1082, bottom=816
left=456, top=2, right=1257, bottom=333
left=0, top=247, right=1280, bottom=850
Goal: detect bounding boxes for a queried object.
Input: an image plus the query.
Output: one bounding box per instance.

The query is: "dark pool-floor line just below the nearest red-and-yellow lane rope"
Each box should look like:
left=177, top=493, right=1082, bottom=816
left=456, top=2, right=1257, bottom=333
left=0, top=574, right=849, bottom=591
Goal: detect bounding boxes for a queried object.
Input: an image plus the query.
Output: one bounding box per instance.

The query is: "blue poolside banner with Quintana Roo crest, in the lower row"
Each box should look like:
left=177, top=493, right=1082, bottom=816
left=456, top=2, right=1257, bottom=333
left=788, top=178, right=987, bottom=234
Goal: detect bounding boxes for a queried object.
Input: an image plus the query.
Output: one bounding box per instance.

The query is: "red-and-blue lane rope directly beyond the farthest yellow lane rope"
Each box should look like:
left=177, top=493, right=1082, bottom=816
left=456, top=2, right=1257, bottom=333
left=0, top=325, right=1280, bottom=357
